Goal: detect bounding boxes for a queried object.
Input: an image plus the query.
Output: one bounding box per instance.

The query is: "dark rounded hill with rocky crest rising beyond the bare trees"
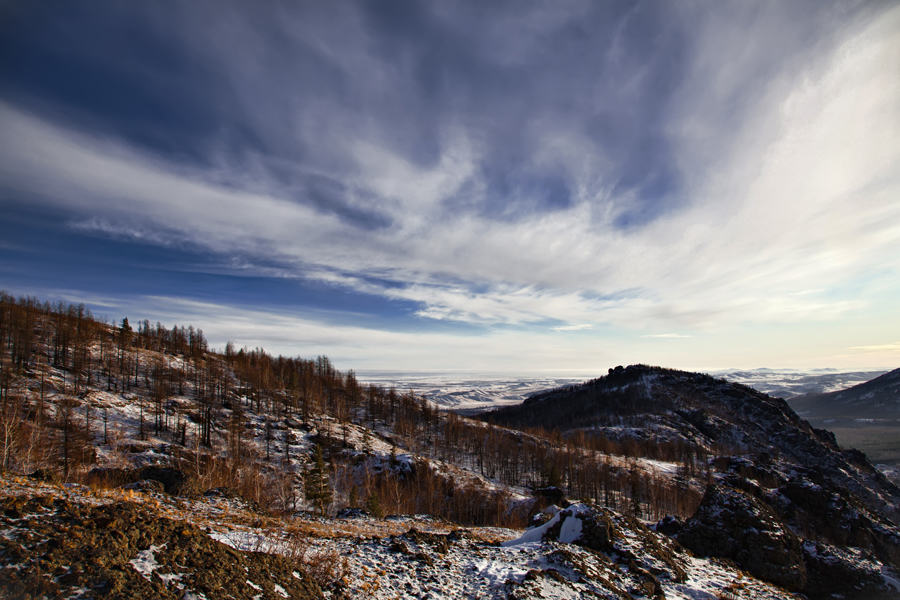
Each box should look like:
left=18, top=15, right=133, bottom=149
left=483, top=365, right=900, bottom=510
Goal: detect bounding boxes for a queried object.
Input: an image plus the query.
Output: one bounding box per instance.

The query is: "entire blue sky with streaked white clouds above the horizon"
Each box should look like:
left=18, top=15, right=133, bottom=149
left=0, top=0, right=900, bottom=375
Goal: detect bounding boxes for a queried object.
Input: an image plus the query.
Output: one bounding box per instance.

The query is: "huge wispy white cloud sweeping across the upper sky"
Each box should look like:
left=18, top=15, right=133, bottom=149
left=0, top=2, right=900, bottom=354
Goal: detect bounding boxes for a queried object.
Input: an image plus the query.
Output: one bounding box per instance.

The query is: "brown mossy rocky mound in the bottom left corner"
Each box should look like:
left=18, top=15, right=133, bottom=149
left=0, top=496, right=322, bottom=600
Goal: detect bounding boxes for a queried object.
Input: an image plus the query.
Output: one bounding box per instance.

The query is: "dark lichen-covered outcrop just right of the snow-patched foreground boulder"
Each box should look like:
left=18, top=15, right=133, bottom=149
left=678, top=484, right=806, bottom=591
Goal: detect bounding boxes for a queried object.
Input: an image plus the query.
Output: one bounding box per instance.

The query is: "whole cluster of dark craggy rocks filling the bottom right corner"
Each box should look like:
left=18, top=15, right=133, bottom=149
left=676, top=477, right=900, bottom=600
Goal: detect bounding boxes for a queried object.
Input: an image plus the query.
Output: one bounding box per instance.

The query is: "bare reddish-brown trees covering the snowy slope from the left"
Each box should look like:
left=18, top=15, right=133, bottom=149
left=0, top=292, right=706, bottom=525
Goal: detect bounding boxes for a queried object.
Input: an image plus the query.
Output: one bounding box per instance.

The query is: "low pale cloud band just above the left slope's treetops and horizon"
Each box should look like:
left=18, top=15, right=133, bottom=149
left=33, top=290, right=613, bottom=374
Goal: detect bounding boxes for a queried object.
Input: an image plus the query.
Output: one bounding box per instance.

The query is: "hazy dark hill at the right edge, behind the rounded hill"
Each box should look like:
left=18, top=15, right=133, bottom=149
left=789, top=369, right=900, bottom=419
